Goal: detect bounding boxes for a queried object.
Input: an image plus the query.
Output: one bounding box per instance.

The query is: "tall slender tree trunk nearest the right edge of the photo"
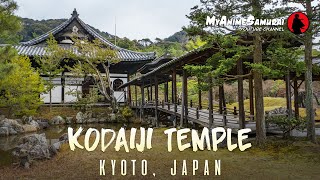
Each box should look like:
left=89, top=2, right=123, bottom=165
left=305, top=0, right=316, bottom=143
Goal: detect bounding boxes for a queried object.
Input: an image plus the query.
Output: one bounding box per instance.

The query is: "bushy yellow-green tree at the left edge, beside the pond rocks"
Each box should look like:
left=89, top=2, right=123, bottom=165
left=0, top=57, right=44, bottom=116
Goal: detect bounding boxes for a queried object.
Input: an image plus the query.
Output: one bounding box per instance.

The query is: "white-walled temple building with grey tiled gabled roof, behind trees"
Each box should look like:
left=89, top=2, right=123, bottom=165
left=14, top=9, right=156, bottom=104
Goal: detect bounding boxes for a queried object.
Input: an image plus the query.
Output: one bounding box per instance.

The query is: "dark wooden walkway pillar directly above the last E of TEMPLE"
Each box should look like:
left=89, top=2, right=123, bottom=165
left=237, top=59, right=246, bottom=129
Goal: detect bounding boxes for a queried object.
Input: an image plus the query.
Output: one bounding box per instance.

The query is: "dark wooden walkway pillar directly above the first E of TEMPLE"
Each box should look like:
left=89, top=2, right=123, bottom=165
left=180, top=70, right=188, bottom=127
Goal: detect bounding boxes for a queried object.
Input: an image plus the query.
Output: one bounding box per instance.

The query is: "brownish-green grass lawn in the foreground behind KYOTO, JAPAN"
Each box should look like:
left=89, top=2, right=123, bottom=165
left=0, top=129, right=320, bottom=179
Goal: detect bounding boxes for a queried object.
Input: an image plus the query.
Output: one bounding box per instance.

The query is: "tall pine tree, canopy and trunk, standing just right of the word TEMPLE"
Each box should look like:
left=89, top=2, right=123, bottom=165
left=184, top=0, right=294, bottom=145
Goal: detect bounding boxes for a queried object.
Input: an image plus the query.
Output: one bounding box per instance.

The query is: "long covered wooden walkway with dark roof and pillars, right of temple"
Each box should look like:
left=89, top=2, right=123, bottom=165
left=120, top=45, right=318, bottom=133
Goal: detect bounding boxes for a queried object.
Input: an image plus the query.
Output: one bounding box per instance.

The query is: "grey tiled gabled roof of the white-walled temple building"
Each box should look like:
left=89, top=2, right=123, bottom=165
left=14, top=11, right=156, bottom=61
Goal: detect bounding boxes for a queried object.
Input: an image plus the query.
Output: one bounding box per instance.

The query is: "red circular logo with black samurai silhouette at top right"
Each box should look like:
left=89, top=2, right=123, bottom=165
left=288, top=12, right=310, bottom=34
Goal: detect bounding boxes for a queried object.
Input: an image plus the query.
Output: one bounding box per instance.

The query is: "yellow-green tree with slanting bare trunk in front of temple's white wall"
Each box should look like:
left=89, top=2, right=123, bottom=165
left=67, top=38, right=119, bottom=108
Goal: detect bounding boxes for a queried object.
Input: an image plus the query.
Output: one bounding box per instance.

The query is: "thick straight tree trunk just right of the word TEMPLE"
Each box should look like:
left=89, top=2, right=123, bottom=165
left=253, top=32, right=266, bottom=146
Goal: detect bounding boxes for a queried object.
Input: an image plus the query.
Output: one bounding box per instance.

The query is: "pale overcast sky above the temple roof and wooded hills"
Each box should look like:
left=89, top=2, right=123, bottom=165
left=16, top=0, right=200, bottom=39
